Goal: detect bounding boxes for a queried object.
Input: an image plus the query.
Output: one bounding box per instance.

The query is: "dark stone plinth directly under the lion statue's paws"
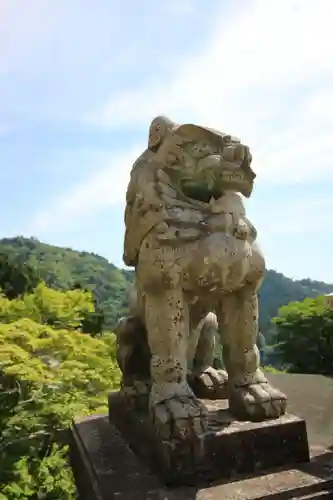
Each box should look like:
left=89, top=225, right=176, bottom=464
left=109, top=392, right=309, bottom=485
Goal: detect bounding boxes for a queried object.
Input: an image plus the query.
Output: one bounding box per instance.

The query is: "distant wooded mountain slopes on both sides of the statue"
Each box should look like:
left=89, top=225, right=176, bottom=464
left=0, top=237, right=333, bottom=336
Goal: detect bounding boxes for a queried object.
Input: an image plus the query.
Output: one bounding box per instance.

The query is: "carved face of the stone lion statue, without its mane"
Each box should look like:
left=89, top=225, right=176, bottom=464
left=155, top=124, right=255, bottom=202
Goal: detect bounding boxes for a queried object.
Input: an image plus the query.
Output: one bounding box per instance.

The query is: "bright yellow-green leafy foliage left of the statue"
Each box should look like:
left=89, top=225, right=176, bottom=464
left=0, top=284, right=120, bottom=500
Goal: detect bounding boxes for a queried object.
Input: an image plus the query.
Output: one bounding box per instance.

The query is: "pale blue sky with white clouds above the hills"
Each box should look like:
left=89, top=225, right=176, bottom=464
left=0, top=0, right=333, bottom=282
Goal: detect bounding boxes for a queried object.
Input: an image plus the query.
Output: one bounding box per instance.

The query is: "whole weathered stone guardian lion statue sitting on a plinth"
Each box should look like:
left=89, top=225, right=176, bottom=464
left=117, top=117, right=286, bottom=437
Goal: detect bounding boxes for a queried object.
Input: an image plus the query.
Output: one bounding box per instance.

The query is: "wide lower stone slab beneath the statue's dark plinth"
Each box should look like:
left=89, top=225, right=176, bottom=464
left=70, top=416, right=333, bottom=500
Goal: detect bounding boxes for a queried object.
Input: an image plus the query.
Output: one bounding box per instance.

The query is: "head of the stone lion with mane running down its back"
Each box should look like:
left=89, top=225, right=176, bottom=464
left=124, top=116, right=255, bottom=266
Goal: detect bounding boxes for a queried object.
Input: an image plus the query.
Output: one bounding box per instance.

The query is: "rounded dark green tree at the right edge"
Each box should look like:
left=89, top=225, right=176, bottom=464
left=274, top=297, right=333, bottom=375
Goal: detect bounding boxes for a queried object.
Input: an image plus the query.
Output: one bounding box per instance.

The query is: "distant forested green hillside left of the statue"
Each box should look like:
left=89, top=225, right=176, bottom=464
left=0, top=237, right=133, bottom=333
